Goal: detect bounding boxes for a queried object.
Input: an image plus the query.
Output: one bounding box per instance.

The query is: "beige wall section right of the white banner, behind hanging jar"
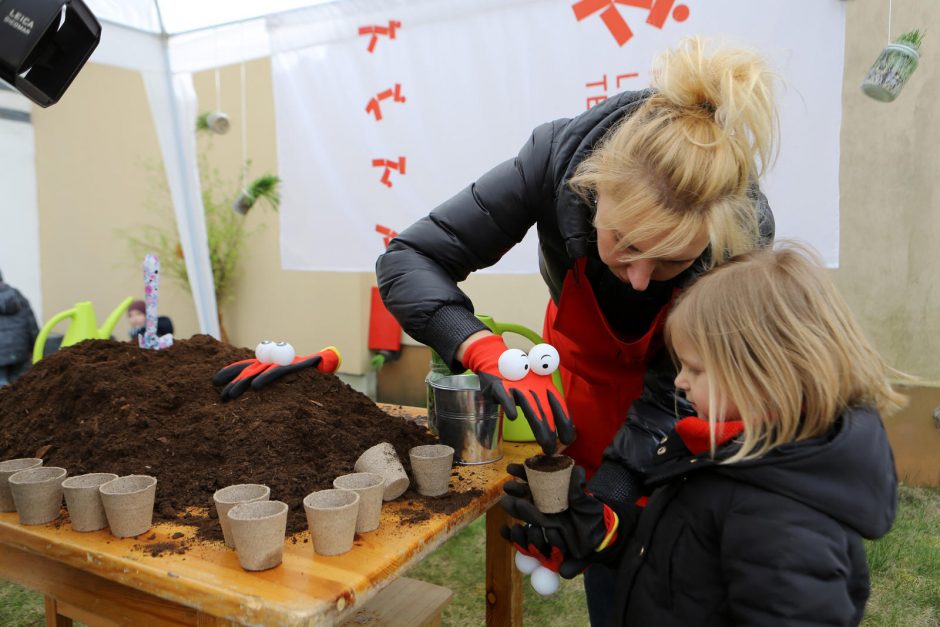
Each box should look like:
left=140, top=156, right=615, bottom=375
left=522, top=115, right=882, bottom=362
left=835, top=0, right=940, bottom=381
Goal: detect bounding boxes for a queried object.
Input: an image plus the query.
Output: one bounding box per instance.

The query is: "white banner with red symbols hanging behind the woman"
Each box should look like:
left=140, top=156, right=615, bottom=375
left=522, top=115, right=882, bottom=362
left=269, top=0, right=845, bottom=274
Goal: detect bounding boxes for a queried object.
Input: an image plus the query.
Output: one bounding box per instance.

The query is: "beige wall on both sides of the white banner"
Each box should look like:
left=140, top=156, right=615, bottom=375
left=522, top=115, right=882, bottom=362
left=33, top=0, right=940, bottom=380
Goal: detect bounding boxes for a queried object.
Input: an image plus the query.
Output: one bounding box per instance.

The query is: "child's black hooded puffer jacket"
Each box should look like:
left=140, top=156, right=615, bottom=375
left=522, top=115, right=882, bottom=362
left=611, top=408, right=897, bottom=627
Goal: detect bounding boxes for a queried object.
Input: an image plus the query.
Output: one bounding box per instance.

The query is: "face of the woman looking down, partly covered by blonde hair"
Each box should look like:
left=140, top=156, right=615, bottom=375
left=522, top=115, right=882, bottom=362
left=597, top=194, right=708, bottom=292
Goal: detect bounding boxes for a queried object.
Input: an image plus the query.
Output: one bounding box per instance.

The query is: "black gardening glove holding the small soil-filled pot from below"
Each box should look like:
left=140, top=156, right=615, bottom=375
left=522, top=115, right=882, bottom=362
left=500, top=464, right=638, bottom=579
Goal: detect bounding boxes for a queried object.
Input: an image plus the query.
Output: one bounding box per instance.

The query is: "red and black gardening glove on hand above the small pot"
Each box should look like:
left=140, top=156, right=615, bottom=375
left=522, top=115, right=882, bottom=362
left=463, top=335, right=575, bottom=455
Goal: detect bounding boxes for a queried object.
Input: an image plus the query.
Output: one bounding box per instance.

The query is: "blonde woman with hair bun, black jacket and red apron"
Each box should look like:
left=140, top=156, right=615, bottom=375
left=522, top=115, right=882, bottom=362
left=376, top=39, right=777, bottom=622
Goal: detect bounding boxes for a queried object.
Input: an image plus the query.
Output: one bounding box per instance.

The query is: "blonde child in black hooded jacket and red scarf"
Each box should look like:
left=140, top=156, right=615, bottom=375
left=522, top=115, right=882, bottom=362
left=509, top=246, right=904, bottom=625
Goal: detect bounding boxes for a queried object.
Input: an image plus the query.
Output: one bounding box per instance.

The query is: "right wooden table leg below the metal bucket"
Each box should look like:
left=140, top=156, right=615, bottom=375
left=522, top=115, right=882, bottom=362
left=486, top=505, right=522, bottom=627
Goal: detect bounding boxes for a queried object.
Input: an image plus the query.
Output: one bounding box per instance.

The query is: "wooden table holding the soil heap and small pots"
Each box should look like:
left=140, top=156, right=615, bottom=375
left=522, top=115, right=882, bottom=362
left=0, top=410, right=538, bottom=625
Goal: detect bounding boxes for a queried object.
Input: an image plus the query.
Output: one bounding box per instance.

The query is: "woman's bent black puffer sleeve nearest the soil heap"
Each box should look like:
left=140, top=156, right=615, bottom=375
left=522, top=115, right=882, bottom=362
left=376, top=123, right=555, bottom=370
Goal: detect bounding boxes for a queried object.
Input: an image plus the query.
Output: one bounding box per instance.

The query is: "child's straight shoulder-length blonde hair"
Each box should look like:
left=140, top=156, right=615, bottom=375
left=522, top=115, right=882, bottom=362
left=666, top=243, right=906, bottom=463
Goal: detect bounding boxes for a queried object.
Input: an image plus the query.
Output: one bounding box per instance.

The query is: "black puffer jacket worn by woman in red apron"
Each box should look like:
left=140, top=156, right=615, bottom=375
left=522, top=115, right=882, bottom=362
left=376, top=90, right=774, bottom=500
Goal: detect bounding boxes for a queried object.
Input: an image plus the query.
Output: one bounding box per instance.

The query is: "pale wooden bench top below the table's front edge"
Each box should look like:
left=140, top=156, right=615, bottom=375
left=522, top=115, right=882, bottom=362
left=339, top=577, right=454, bottom=627
